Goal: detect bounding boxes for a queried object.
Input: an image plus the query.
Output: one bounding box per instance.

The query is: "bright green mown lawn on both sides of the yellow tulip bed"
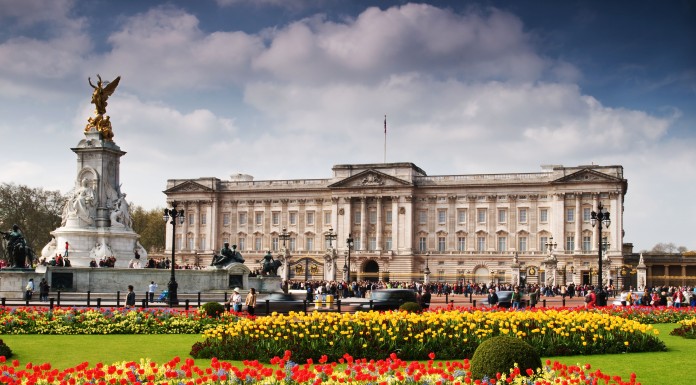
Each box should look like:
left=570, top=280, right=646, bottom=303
left=0, top=324, right=696, bottom=385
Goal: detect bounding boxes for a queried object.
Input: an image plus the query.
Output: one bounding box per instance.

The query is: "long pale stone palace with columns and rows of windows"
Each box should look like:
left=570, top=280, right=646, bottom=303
left=164, top=163, right=628, bottom=285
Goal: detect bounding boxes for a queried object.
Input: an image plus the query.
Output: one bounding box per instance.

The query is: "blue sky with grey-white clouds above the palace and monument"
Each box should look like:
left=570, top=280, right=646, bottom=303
left=0, top=0, right=696, bottom=250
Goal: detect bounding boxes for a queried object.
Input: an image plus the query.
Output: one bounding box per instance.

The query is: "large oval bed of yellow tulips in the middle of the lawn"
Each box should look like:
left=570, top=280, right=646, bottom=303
left=191, top=309, right=665, bottom=360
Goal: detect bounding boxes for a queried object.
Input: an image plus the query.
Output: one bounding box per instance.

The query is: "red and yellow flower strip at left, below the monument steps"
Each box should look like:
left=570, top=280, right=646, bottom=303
left=0, top=307, right=237, bottom=334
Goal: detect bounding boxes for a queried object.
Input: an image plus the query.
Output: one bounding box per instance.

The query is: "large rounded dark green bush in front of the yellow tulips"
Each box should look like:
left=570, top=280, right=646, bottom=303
left=471, top=336, right=541, bottom=379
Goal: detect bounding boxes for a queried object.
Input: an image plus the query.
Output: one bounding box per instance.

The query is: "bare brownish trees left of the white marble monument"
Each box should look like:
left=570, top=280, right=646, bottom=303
left=0, top=183, right=68, bottom=257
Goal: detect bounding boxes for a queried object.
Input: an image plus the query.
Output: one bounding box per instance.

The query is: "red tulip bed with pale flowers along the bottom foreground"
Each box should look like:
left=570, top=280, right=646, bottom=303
left=0, top=352, right=640, bottom=385
